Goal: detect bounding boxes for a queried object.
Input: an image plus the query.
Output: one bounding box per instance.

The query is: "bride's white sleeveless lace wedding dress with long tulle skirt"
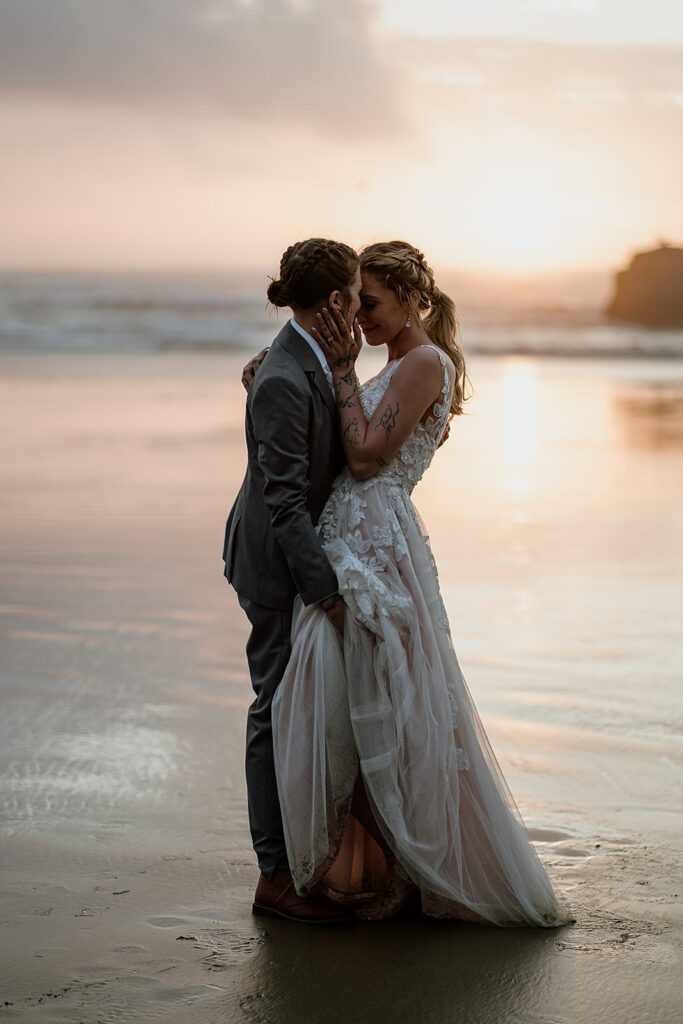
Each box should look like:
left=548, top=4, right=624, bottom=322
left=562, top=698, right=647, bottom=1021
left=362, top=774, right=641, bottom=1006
left=272, top=349, right=568, bottom=926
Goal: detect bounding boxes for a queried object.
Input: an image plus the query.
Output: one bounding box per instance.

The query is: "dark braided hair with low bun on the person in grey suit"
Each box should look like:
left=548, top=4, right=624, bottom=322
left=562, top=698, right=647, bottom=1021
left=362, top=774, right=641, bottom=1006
left=267, top=239, right=358, bottom=309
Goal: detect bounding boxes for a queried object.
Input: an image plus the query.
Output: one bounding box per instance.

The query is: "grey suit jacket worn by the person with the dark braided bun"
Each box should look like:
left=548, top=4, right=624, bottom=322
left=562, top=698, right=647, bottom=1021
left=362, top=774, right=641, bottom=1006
left=223, top=324, right=344, bottom=609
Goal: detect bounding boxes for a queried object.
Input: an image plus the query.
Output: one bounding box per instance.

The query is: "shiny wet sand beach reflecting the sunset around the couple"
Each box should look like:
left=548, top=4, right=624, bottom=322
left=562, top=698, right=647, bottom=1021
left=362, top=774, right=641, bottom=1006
left=0, top=353, right=683, bottom=1024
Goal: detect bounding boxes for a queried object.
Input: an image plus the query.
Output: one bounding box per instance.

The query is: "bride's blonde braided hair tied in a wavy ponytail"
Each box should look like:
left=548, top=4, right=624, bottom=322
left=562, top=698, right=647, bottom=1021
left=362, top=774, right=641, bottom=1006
left=360, top=242, right=470, bottom=416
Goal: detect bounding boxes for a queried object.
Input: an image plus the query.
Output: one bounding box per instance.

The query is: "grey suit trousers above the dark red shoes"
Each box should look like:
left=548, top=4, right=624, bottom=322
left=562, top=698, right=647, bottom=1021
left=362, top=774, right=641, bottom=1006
left=238, top=594, right=292, bottom=879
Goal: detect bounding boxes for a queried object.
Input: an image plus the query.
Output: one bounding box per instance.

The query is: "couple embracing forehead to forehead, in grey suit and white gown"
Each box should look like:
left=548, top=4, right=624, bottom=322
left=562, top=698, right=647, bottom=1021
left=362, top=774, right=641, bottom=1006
left=223, top=239, right=567, bottom=927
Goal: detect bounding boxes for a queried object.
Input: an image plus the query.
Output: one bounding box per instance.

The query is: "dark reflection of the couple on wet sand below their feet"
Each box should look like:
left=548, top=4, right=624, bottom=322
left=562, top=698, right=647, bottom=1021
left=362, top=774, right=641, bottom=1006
left=237, top=915, right=579, bottom=1024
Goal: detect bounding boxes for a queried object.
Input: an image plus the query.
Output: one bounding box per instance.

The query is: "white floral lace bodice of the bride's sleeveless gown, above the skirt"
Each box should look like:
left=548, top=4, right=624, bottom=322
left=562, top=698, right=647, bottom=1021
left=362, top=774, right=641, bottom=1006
left=335, top=345, right=453, bottom=494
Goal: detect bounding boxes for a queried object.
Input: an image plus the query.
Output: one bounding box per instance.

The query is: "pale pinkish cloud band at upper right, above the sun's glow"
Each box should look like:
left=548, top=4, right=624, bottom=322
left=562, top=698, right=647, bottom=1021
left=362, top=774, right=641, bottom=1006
left=395, top=37, right=683, bottom=191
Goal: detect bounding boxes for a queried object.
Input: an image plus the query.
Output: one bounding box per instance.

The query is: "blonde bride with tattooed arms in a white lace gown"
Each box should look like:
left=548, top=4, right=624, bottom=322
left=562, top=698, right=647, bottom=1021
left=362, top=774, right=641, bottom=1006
left=272, top=243, right=568, bottom=927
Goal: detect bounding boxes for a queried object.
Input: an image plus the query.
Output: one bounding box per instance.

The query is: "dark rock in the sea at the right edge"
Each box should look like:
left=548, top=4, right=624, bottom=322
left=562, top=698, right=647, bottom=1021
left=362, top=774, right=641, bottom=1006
left=605, top=242, right=683, bottom=328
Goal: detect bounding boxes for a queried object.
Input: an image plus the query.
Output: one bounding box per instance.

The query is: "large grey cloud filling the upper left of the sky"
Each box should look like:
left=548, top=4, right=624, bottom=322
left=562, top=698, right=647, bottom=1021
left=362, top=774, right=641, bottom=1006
left=0, top=0, right=404, bottom=139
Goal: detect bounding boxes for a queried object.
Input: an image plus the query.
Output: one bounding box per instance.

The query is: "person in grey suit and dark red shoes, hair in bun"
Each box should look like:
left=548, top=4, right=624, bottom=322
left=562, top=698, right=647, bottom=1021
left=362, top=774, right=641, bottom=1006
left=223, top=239, right=360, bottom=924
